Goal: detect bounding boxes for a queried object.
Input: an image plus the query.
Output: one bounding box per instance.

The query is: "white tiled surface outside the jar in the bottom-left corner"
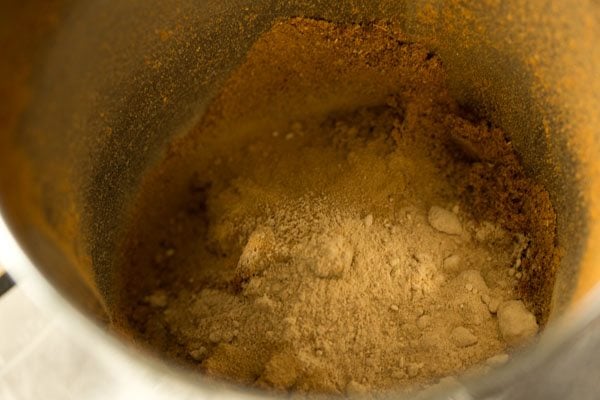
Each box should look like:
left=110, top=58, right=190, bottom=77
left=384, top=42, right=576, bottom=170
left=0, top=287, right=114, bottom=400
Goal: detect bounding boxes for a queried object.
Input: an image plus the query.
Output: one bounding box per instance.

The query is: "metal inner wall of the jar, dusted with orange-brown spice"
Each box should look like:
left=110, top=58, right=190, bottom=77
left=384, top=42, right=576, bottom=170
left=0, top=0, right=600, bottom=394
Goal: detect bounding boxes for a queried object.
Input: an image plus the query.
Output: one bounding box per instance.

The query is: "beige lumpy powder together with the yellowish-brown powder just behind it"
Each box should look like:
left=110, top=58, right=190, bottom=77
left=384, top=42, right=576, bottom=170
left=149, top=111, right=535, bottom=392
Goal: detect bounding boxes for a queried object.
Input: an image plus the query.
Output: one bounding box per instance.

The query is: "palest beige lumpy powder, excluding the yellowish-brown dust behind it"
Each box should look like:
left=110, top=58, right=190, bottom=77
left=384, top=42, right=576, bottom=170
left=188, top=198, right=524, bottom=392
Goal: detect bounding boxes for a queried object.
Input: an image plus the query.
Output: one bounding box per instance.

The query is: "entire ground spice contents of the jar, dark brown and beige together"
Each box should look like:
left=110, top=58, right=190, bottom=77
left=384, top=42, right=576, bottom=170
left=115, top=19, right=558, bottom=394
